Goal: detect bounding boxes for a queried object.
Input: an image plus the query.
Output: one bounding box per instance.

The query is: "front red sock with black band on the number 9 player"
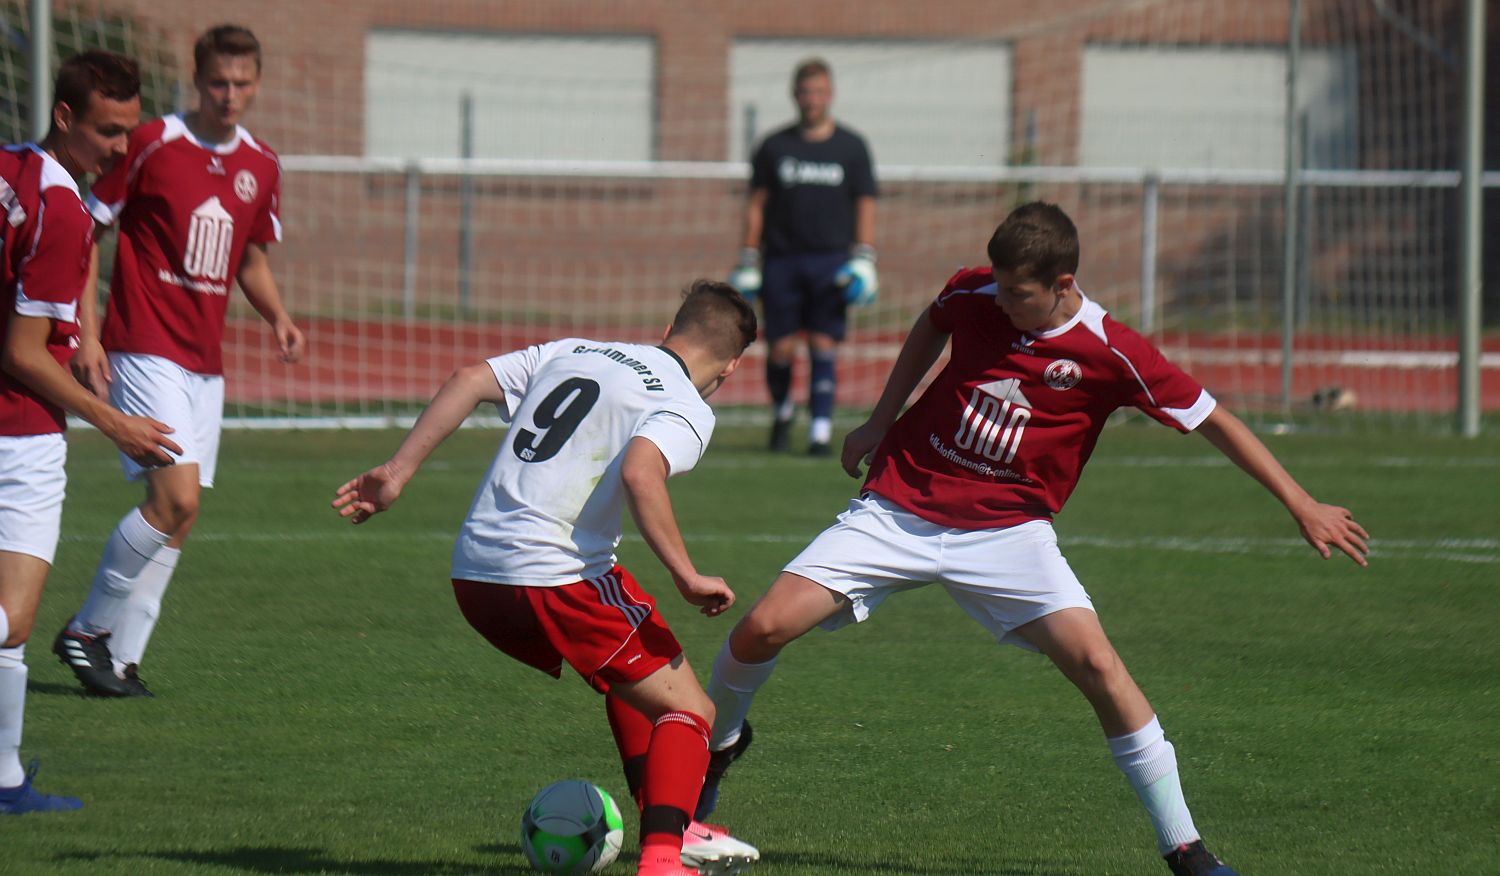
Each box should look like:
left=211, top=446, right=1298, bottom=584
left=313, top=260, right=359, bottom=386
left=641, top=711, right=711, bottom=855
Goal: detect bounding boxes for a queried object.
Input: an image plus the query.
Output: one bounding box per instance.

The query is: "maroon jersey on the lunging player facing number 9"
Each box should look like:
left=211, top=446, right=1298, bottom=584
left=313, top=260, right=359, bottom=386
left=866, top=269, right=1215, bottom=530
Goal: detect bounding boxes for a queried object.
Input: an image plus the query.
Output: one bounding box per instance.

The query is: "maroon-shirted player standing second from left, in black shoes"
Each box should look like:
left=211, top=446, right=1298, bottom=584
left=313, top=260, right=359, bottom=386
left=53, top=24, right=305, bottom=696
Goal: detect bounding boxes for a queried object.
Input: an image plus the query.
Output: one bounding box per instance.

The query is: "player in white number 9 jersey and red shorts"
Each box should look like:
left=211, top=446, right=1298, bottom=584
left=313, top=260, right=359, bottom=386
left=333, top=281, right=759, bottom=876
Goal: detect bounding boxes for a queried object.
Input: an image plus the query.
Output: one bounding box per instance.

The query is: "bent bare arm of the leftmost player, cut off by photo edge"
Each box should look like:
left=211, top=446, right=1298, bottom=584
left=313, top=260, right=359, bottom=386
left=0, top=314, right=183, bottom=468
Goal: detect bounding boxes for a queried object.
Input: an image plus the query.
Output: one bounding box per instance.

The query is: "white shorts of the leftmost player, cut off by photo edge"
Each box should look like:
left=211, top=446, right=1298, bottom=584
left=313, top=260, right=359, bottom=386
left=0, top=432, right=68, bottom=564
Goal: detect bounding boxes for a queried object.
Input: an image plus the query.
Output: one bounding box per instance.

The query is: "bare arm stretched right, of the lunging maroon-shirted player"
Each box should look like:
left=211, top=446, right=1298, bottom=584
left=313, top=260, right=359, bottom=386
left=1197, top=405, right=1370, bottom=566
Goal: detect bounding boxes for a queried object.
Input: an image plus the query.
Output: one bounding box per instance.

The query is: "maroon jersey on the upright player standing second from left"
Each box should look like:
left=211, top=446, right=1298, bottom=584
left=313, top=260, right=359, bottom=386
left=89, top=116, right=281, bottom=374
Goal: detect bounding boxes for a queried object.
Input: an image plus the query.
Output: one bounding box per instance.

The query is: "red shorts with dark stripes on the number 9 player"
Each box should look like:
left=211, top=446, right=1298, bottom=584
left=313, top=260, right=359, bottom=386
left=453, top=566, right=683, bottom=693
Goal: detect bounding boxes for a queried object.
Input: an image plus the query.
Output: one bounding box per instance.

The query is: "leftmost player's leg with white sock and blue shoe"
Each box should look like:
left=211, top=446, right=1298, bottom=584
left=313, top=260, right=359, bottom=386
left=0, top=551, right=83, bottom=815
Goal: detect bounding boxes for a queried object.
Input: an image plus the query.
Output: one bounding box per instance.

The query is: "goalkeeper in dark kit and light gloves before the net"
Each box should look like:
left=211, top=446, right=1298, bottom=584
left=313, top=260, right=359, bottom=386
left=729, top=59, right=879, bottom=456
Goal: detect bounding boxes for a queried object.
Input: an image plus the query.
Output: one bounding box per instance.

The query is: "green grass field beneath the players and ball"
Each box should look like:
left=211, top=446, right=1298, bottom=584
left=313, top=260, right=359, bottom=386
left=0, top=423, right=1500, bottom=876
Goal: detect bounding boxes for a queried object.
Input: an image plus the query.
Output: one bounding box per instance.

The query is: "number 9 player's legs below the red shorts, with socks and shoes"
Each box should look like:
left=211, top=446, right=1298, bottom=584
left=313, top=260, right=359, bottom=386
left=608, top=654, right=761, bottom=875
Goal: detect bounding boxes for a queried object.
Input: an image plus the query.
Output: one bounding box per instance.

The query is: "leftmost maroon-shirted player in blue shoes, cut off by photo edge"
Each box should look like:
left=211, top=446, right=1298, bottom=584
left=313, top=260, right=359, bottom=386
left=0, top=51, right=180, bottom=815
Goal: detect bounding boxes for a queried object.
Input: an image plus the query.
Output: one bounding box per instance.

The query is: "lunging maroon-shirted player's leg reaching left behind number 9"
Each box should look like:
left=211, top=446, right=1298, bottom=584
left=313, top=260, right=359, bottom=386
left=693, top=572, right=849, bottom=821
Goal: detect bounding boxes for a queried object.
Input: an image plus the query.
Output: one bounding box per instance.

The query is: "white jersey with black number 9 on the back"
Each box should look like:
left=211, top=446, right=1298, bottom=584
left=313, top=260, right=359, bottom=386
left=453, top=338, right=714, bottom=587
